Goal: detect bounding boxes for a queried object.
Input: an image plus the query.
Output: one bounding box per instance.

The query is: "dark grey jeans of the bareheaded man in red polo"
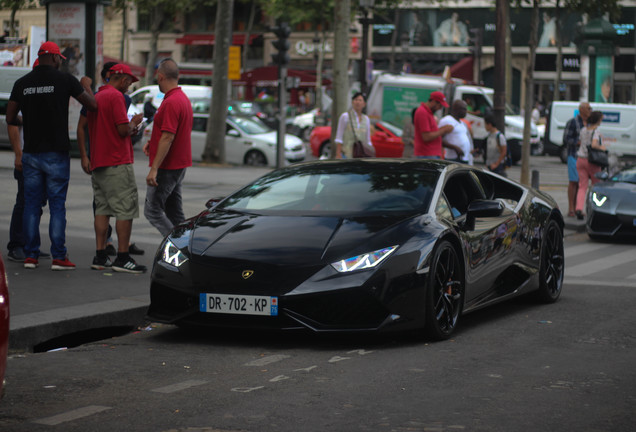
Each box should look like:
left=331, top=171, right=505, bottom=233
left=144, top=168, right=186, bottom=237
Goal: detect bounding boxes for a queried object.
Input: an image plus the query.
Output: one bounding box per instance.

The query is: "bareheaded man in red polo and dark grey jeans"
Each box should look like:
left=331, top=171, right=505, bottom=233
left=144, top=58, right=192, bottom=236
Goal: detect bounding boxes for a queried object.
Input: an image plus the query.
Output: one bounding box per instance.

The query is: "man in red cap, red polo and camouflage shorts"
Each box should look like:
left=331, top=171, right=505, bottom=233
left=87, top=64, right=146, bottom=274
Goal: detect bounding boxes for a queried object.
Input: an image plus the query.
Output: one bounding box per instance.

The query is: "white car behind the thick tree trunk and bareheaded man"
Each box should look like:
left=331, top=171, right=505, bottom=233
left=144, top=113, right=306, bottom=167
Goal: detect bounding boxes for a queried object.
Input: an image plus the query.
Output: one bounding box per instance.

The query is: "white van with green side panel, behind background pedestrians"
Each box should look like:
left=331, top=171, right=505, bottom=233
left=367, top=73, right=539, bottom=162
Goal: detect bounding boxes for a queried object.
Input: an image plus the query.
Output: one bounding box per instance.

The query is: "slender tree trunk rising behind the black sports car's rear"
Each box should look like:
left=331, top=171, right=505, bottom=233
left=520, top=0, right=539, bottom=186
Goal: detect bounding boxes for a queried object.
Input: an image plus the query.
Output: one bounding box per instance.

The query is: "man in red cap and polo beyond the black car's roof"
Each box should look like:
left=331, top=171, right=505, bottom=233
left=413, top=91, right=453, bottom=159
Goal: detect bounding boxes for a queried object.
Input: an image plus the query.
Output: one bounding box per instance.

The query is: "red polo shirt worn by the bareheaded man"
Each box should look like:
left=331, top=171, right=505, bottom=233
left=148, top=87, right=192, bottom=169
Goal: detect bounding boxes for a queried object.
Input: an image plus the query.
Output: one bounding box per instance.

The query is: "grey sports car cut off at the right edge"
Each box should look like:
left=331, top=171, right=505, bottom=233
left=585, top=166, right=636, bottom=238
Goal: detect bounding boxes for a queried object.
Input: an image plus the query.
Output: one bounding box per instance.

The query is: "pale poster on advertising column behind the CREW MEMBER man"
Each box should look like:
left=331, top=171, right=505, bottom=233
left=47, top=3, right=86, bottom=140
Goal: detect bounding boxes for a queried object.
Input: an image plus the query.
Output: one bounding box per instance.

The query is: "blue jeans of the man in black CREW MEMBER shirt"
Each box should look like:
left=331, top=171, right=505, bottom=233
left=22, top=152, right=71, bottom=259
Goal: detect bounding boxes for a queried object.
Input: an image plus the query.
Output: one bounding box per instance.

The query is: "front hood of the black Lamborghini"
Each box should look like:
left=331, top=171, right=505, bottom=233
left=191, top=211, right=403, bottom=266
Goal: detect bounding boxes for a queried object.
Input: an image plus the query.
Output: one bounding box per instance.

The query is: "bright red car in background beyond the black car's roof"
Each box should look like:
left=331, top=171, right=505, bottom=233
left=309, top=121, right=404, bottom=159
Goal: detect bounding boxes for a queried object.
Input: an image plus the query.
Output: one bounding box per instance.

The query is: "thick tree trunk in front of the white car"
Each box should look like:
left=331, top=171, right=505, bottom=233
left=202, top=0, right=234, bottom=163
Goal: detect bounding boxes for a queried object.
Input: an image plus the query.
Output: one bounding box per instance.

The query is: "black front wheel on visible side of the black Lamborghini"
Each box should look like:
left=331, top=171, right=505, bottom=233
left=425, top=240, right=464, bottom=340
